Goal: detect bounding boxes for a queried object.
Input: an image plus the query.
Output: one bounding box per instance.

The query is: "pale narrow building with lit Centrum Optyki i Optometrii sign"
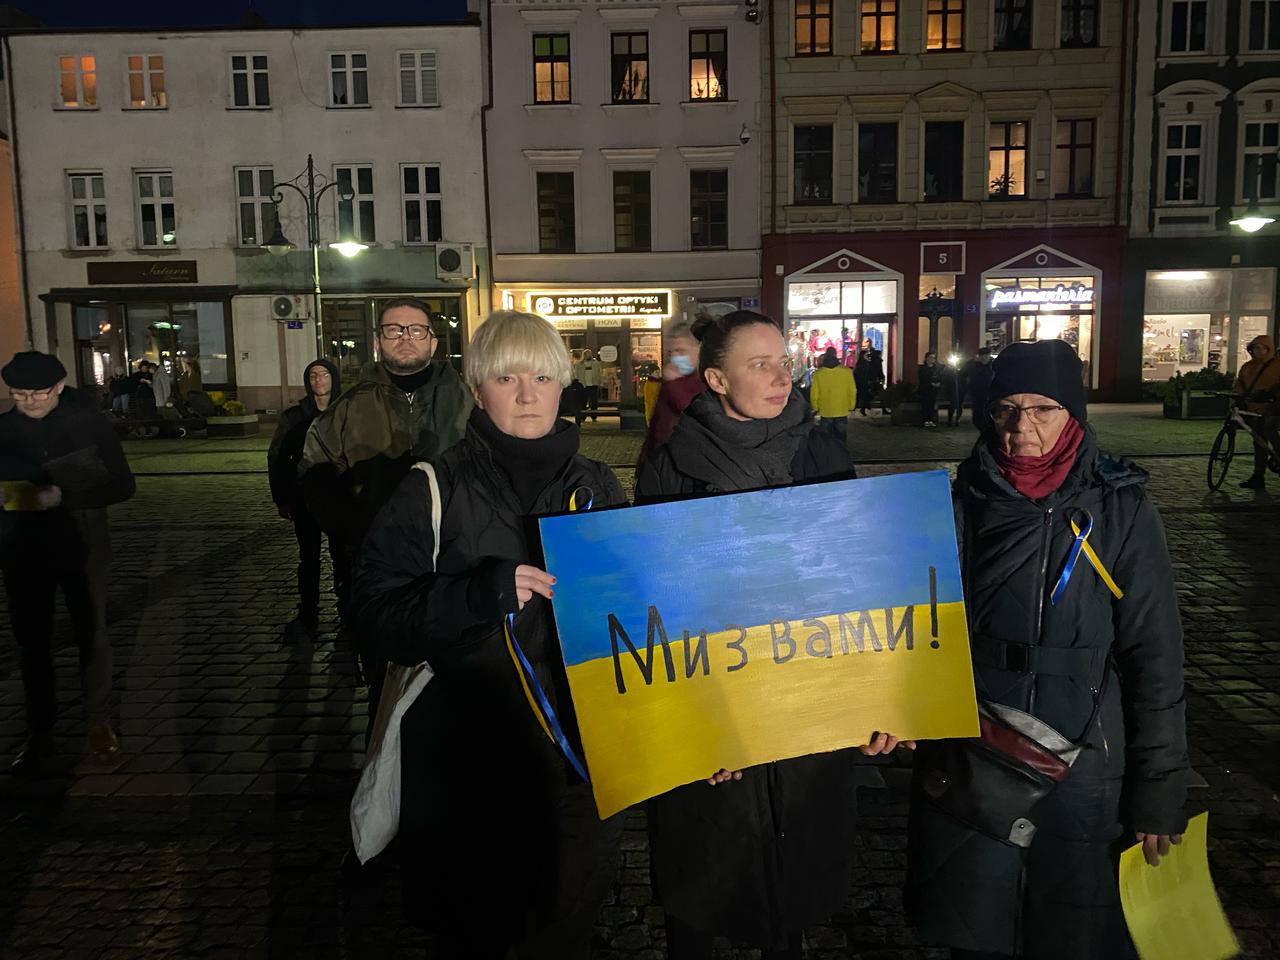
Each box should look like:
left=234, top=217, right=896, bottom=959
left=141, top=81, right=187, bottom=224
left=486, top=0, right=760, bottom=404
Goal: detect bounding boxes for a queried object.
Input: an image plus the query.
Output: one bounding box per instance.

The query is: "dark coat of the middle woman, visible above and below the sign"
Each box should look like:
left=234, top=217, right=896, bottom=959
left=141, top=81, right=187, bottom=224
left=636, top=394, right=855, bottom=947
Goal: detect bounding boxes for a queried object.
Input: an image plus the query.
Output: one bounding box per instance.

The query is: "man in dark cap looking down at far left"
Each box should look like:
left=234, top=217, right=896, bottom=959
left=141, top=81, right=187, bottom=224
left=0, top=351, right=134, bottom=774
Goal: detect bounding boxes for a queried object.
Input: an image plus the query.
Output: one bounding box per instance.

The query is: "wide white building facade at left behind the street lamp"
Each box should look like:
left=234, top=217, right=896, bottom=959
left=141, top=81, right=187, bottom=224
left=6, top=19, right=490, bottom=411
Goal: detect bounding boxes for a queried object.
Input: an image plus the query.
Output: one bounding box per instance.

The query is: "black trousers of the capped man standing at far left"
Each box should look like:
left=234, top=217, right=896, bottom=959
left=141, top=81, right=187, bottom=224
left=4, top=509, right=111, bottom=736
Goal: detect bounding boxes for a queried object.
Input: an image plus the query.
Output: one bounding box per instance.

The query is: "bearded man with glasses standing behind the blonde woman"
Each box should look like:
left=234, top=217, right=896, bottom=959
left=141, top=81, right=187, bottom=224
left=298, top=297, right=472, bottom=680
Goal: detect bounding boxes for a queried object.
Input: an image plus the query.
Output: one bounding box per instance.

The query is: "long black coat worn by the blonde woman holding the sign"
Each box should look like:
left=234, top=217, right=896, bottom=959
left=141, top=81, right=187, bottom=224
left=353, top=411, right=626, bottom=929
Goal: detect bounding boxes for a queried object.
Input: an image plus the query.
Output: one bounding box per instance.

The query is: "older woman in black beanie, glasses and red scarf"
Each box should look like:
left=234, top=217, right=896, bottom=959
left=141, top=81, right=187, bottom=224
left=906, top=340, right=1188, bottom=960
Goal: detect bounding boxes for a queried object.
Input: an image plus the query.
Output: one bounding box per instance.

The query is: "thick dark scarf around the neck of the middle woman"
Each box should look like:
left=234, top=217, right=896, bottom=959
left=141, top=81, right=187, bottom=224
left=668, top=390, right=813, bottom=493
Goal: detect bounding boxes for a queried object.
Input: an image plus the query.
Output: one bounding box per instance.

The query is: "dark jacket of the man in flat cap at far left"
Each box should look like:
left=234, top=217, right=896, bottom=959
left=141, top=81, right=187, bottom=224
left=0, top=387, right=136, bottom=562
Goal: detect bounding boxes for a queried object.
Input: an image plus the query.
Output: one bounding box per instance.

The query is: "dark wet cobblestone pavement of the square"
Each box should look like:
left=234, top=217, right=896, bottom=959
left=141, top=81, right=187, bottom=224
left=0, top=433, right=1280, bottom=960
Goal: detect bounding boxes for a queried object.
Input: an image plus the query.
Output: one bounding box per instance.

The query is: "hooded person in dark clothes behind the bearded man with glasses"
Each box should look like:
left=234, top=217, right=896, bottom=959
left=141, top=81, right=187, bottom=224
left=266, top=360, right=346, bottom=640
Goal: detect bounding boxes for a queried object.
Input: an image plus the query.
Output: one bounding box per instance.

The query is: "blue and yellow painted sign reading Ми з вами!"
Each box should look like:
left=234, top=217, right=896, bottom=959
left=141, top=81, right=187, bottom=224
left=540, top=471, right=978, bottom=817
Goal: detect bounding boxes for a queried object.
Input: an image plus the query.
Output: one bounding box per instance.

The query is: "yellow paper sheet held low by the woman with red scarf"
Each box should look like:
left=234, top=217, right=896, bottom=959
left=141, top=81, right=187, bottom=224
left=1120, top=813, right=1240, bottom=960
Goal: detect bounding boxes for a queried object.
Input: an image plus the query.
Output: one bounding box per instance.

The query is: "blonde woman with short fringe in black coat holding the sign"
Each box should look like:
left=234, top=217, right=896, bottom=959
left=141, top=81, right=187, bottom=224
left=353, top=311, right=626, bottom=960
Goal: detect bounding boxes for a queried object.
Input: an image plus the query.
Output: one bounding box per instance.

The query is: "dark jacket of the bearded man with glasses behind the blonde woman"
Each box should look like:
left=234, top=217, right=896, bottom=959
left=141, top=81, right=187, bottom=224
left=298, top=361, right=474, bottom=545
